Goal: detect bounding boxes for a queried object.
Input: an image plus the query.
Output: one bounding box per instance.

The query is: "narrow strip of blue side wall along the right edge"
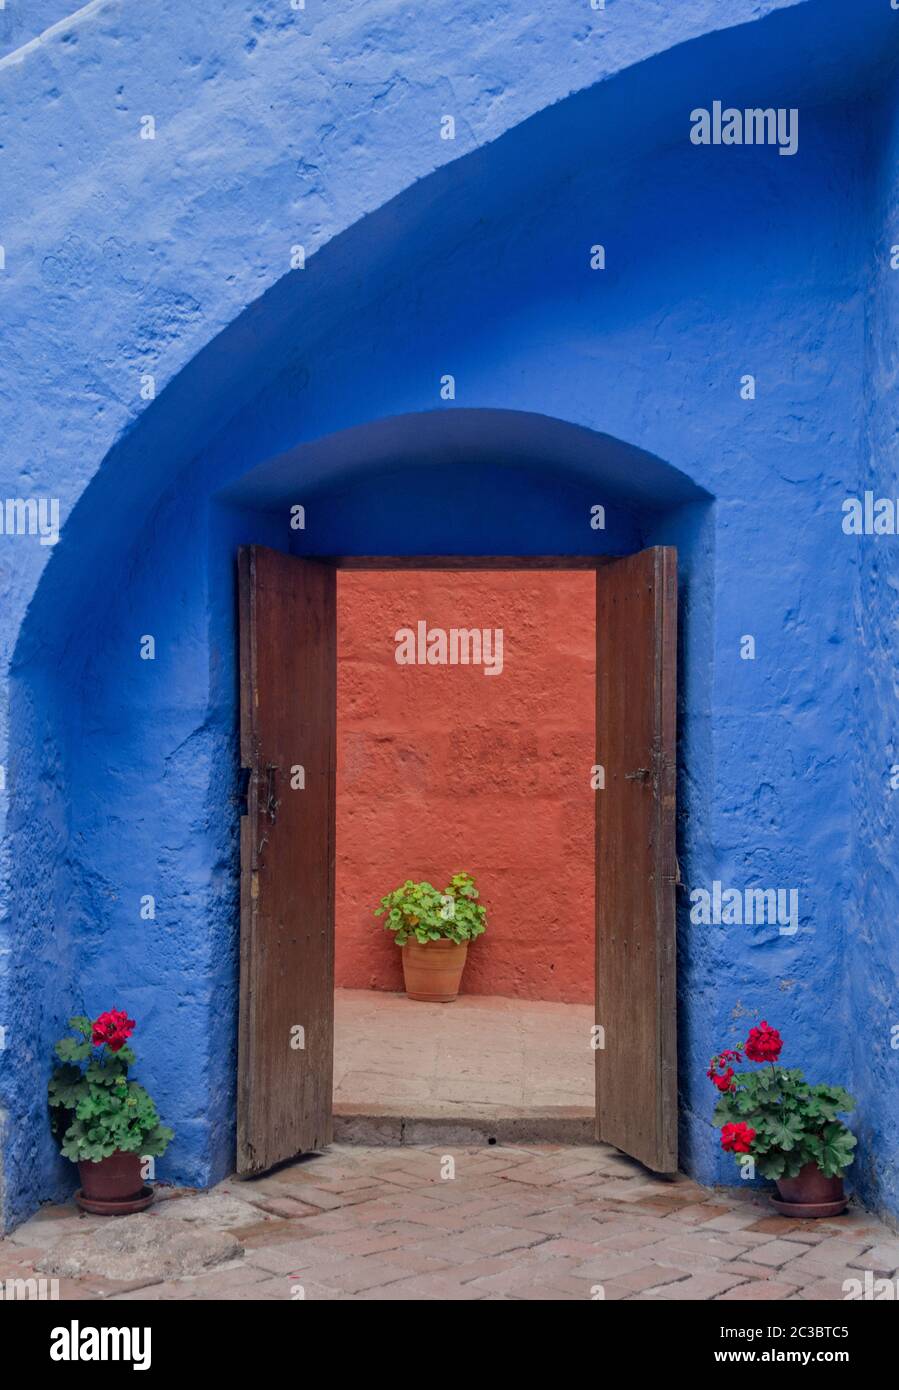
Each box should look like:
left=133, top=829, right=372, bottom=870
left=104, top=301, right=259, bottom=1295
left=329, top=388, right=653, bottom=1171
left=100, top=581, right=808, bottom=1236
left=842, top=73, right=899, bottom=1213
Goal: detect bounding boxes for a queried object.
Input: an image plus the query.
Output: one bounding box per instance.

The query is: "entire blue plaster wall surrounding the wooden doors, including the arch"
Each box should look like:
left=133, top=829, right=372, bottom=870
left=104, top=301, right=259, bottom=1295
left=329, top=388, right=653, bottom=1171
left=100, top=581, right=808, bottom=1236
left=0, top=0, right=899, bottom=1220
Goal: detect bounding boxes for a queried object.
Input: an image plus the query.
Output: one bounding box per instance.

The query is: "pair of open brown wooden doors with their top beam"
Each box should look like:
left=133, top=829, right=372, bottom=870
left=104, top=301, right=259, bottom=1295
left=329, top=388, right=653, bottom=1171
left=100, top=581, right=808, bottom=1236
left=238, top=546, right=677, bottom=1176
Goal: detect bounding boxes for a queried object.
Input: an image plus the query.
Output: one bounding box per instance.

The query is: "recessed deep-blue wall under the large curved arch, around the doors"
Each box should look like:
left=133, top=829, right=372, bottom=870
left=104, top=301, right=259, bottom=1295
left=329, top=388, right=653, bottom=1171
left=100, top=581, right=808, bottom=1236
left=1, top=0, right=896, bottom=1219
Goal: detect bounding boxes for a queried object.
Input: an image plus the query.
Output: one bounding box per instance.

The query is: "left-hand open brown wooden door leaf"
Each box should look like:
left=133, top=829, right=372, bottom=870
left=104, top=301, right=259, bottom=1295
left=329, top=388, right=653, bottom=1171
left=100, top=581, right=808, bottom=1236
left=238, top=546, right=336, bottom=1176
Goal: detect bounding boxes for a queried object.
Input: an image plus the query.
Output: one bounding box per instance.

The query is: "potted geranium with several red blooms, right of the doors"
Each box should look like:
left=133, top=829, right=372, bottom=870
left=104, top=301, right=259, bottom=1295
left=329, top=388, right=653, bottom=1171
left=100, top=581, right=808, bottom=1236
left=707, top=1019, right=856, bottom=1216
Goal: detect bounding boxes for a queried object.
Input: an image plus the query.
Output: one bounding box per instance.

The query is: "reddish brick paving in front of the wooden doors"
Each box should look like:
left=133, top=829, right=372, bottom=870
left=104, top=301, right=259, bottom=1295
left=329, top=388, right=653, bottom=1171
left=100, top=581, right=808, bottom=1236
left=0, top=1145, right=899, bottom=1300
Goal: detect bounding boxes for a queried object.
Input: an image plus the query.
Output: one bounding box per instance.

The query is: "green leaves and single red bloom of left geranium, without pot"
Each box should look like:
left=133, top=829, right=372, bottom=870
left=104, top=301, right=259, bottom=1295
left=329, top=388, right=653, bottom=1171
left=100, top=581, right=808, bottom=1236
left=49, top=1011, right=174, bottom=1163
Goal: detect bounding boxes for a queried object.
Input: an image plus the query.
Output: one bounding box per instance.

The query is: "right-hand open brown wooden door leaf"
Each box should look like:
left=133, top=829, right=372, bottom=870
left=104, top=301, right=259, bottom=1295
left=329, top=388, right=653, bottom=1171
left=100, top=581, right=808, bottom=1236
left=596, top=546, right=677, bottom=1173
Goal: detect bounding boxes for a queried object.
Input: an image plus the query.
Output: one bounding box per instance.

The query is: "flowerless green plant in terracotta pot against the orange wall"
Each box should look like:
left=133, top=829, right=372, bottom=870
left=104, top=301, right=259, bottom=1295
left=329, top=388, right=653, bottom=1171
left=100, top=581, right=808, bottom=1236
left=374, top=873, right=486, bottom=1004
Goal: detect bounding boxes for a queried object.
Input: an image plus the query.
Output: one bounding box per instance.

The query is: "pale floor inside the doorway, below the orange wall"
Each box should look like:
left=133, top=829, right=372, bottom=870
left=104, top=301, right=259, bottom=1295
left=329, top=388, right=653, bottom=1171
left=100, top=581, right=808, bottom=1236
left=333, top=990, right=595, bottom=1118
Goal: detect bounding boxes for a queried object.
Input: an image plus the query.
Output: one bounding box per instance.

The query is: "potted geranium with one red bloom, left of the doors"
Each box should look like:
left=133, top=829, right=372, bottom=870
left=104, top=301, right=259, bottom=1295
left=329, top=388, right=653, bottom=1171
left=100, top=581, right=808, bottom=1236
left=49, top=1009, right=174, bottom=1215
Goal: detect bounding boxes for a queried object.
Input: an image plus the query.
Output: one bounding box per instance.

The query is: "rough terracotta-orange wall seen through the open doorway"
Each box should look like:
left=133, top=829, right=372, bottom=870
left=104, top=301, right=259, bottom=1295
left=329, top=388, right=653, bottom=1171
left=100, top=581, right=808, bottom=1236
left=336, top=571, right=595, bottom=1002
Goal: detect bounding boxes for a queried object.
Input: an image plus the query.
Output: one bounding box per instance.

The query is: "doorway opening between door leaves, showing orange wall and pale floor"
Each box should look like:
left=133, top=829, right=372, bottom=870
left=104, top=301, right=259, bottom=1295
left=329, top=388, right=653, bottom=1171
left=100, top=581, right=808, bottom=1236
left=333, top=569, right=596, bottom=1141
